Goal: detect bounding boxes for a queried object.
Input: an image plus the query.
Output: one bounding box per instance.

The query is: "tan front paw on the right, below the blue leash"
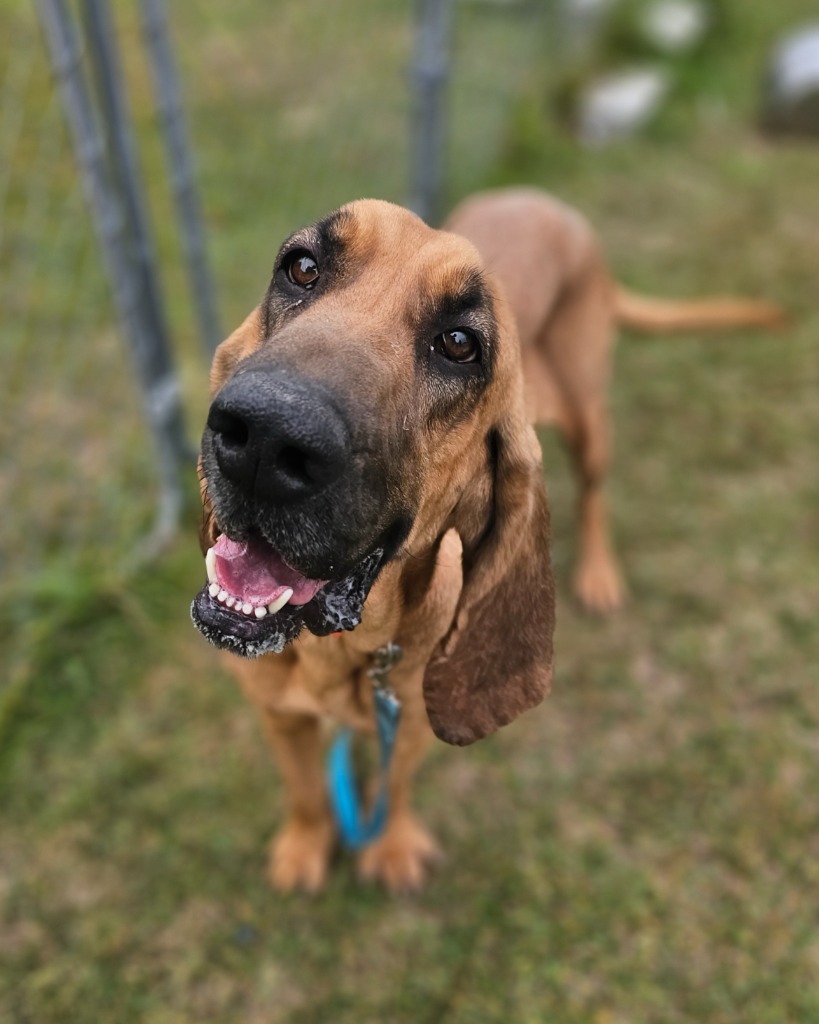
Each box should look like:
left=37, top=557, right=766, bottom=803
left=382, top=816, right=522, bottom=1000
left=358, top=814, right=441, bottom=893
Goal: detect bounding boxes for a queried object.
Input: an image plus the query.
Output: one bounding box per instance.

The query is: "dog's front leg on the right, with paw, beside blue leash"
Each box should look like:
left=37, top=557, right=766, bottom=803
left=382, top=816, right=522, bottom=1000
left=358, top=671, right=440, bottom=892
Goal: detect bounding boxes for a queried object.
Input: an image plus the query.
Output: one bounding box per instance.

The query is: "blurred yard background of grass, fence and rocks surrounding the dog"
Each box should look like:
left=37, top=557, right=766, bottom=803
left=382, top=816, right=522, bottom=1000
left=0, top=0, right=819, bottom=1024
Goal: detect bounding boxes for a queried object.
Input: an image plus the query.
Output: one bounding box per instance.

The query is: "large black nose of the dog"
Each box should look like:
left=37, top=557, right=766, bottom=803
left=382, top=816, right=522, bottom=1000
left=208, top=370, right=350, bottom=505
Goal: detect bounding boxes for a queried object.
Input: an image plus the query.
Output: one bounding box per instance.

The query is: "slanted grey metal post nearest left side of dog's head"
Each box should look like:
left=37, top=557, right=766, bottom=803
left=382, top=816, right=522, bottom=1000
left=140, top=0, right=222, bottom=356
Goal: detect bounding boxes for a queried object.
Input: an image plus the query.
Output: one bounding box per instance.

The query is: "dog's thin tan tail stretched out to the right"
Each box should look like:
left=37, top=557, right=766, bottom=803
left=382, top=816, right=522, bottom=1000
left=614, top=285, right=787, bottom=332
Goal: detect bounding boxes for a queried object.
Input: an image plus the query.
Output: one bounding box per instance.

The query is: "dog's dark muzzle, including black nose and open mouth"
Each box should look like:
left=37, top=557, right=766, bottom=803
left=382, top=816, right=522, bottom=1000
left=191, top=368, right=399, bottom=657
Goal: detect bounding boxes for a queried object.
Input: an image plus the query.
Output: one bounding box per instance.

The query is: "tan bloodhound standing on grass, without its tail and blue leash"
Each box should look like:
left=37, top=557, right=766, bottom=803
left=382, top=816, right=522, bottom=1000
left=191, top=190, right=782, bottom=892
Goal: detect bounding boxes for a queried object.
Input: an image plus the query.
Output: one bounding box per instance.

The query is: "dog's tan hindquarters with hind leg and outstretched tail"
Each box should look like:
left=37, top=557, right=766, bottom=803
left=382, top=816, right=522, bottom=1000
left=444, top=188, right=784, bottom=612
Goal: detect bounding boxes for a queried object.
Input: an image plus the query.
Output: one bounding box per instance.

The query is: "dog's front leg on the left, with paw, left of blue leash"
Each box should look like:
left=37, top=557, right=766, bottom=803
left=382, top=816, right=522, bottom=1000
left=255, top=710, right=335, bottom=893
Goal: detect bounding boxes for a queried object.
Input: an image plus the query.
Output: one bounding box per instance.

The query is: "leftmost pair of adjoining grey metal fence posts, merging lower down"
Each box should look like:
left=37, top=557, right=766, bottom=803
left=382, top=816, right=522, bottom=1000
left=37, top=0, right=189, bottom=543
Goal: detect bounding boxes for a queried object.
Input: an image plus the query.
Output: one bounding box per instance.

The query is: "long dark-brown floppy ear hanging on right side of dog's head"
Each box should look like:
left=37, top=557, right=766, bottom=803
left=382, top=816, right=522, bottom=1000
left=424, top=413, right=555, bottom=745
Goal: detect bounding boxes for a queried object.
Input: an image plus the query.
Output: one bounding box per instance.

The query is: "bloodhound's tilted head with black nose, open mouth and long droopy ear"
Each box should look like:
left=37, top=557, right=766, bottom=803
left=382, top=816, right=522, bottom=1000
left=193, top=200, right=554, bottom=743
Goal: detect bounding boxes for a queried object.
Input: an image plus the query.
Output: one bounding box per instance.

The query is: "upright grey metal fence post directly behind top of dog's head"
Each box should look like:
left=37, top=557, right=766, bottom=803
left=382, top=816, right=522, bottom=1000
left=410, top=0, right=452, bottom=223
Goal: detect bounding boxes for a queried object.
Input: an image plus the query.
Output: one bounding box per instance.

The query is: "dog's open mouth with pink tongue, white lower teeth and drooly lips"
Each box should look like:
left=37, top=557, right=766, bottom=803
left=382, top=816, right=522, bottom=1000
left=190, top=534, right=384, bottom=657
